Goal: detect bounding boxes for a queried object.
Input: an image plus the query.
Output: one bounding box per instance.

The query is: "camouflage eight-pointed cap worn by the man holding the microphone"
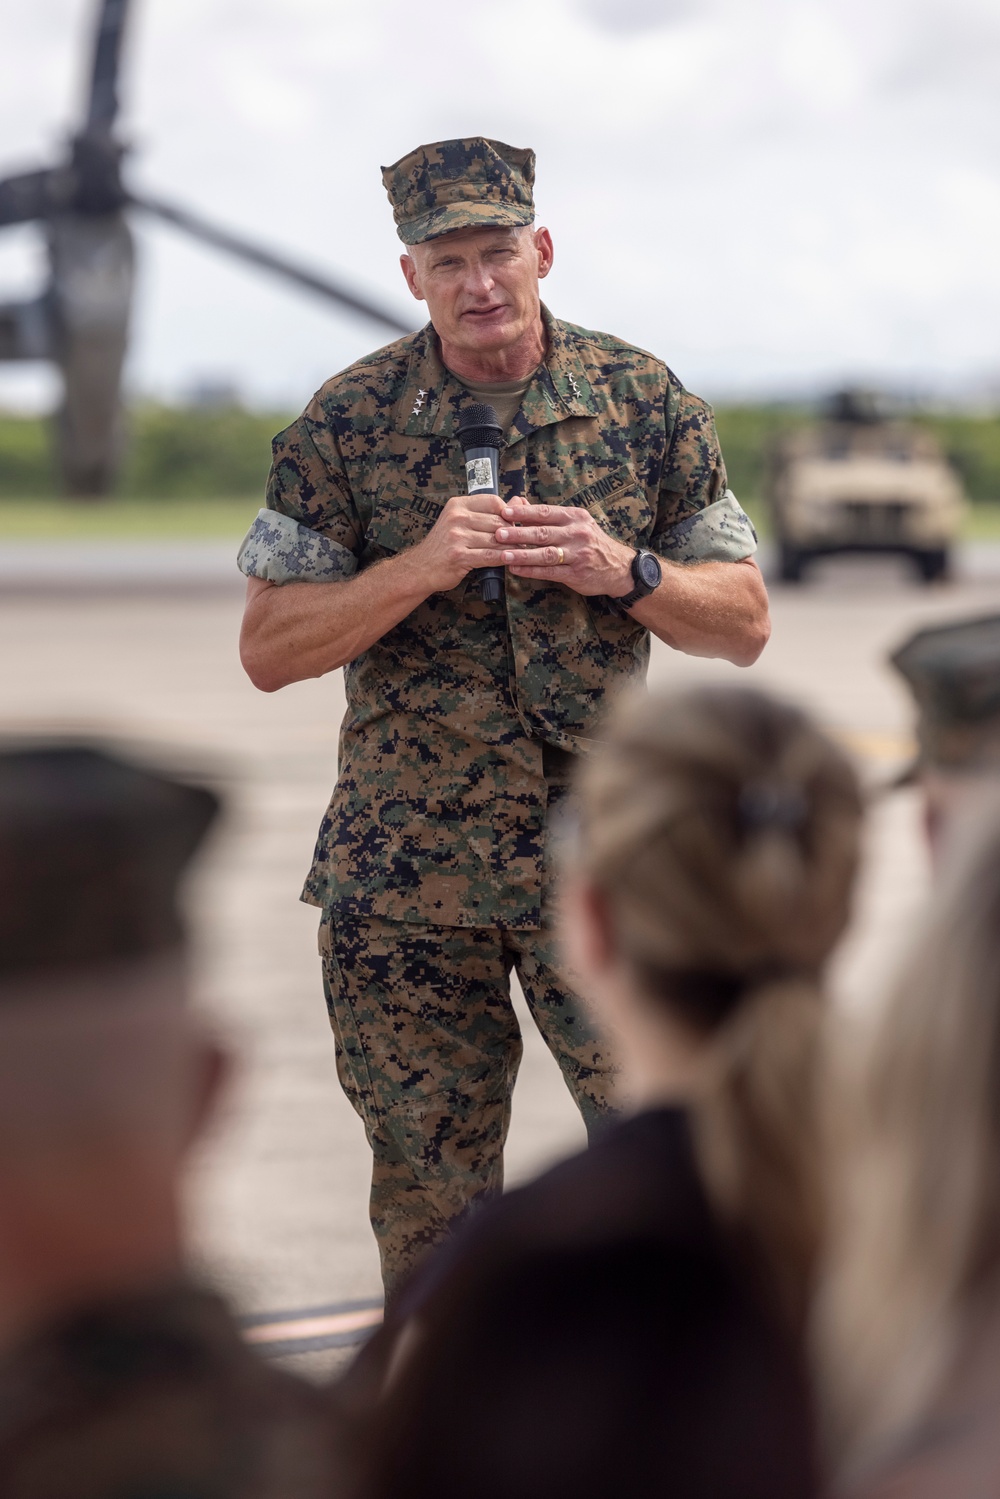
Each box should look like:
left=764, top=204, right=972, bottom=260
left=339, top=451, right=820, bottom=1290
left=382, top=135, right=535, bottom=244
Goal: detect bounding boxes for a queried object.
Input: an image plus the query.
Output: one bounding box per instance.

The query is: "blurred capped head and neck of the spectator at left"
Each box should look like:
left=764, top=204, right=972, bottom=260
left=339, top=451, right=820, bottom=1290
left=0, top=745, right=222, bottom=1345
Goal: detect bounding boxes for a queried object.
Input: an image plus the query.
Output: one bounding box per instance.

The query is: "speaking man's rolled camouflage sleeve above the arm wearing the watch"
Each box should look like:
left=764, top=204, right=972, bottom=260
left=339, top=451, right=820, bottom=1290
left=651, top=384, right=757, bottom=562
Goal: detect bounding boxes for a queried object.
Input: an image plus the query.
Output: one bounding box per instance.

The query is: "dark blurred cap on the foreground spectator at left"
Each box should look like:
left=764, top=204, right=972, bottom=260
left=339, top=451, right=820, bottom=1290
left=0, top=744, right=219, bottom=992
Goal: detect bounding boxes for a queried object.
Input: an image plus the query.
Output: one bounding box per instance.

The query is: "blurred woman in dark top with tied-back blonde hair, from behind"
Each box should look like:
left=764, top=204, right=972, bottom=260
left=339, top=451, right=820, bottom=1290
left=334, top=688, right=861, bottom=1499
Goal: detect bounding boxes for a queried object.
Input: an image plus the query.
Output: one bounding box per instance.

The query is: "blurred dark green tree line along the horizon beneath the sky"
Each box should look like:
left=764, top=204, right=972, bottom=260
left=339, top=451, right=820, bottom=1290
left=0, top=403, right=1000, bottom=504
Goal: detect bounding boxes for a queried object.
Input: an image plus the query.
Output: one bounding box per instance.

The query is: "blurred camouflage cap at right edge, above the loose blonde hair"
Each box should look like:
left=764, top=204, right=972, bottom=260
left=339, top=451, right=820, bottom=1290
left=891, top=615, right=1000, bottom=770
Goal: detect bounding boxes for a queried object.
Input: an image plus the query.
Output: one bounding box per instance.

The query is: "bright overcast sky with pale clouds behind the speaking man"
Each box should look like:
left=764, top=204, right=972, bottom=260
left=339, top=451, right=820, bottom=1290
left=0, top=0, right=1000, bottom=408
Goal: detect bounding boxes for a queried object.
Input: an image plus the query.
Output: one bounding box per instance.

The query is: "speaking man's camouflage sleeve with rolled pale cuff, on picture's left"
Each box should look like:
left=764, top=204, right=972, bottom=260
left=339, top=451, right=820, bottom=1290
left=238, top=397, right=364, bottom=583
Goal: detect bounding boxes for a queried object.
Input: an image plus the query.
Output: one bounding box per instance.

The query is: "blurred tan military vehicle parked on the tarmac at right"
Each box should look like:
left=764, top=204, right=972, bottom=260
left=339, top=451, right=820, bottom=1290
left=766, top=391, right=964, bottom=583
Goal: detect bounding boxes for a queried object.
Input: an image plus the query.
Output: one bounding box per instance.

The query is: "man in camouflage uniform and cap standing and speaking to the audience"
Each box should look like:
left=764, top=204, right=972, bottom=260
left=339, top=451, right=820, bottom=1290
left=240, top=136, right=769, bottom=1295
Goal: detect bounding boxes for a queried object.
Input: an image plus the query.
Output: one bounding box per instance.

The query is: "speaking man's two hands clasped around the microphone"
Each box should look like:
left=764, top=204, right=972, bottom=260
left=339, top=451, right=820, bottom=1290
left=414, top=495, right=634, bottom=598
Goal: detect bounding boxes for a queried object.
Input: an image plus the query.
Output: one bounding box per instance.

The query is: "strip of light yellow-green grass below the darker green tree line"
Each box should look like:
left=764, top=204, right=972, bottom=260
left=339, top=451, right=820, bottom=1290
left=0, top=495, right=1000, bottom=543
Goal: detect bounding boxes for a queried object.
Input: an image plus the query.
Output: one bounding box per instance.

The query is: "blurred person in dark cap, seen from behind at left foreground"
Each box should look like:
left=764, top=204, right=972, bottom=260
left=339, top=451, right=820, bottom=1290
left=0, top=745, right=328, bottom=1499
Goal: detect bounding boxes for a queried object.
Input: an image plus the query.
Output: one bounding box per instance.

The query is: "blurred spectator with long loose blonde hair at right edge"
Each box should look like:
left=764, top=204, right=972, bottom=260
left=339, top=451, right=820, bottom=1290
left=817, top=788, right=1000, bottom=1499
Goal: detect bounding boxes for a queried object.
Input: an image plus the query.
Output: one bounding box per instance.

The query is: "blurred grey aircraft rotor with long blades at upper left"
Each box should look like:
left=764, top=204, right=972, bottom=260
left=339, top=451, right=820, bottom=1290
left=0, top=0, right=412, bottom=498
